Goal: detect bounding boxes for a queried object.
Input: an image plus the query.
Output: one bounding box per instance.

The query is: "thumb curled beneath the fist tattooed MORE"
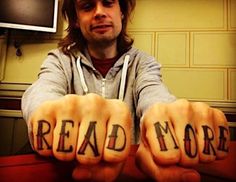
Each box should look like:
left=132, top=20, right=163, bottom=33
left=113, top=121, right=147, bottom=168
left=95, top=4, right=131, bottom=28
left=136, top=143, right=200, bottom=182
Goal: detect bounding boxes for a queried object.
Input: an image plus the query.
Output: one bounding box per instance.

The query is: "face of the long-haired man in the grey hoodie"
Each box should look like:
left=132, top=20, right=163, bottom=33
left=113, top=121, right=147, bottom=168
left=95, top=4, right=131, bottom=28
left=76, top=0, right=123, bottom=45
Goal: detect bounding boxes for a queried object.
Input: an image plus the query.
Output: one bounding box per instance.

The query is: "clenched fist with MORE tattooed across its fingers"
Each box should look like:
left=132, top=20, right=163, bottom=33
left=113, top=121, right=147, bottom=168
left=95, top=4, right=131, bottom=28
left=136, top=99, right=229, bottom=181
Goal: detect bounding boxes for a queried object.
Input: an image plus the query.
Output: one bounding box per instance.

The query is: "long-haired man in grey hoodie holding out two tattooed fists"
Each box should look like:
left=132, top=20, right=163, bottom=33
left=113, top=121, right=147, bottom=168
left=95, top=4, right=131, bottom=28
left=22, top=0, right=229, bottom=181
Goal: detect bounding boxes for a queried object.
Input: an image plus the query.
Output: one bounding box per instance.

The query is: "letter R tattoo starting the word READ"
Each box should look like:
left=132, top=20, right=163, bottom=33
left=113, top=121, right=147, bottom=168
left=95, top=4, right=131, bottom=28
left=36, top=120, right=52, bottom=150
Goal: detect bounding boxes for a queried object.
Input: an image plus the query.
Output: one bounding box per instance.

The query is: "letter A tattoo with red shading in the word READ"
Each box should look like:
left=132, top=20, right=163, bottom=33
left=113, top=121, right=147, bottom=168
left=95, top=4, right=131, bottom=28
left=78, top=121, right=99, bottom=156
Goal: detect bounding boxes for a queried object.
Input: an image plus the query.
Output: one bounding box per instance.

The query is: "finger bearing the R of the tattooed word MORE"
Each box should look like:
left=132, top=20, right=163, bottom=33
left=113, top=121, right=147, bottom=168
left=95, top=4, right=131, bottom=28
left=192, top=102, right=216, bottom=162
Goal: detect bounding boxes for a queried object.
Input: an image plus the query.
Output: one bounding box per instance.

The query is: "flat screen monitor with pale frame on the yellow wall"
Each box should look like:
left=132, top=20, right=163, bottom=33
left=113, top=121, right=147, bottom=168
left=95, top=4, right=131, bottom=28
left=0, top=0, right=58, bottom=32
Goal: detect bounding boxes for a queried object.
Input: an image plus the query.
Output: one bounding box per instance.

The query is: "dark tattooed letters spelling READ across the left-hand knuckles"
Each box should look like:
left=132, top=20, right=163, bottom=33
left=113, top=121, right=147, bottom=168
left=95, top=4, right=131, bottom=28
left=36, top=120, right=127, bottom=157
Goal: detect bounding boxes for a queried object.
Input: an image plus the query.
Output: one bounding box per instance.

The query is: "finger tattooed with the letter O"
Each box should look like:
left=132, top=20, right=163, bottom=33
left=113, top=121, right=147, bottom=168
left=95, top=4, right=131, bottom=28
left=168, top=99, right=199, bottom=166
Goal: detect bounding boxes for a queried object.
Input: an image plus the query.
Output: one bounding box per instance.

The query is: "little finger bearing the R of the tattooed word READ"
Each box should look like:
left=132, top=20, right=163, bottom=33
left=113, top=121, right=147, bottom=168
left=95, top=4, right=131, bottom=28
left=30, top=101, right=56, bottom=156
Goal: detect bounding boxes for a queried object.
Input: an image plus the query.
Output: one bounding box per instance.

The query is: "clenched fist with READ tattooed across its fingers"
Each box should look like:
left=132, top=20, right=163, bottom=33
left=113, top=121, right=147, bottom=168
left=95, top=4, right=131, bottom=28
left=30, top=94, right=131, bottom=181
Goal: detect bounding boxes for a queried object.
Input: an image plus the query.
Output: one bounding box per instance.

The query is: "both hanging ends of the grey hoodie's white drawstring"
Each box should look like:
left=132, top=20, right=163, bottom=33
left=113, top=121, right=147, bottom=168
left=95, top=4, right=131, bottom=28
left=76, top=54, right=130, bottom=100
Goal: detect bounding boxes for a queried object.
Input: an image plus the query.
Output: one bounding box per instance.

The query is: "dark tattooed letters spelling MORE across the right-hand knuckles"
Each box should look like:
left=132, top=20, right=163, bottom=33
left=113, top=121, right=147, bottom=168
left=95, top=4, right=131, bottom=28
left=154, top=121, right=229, bottom=158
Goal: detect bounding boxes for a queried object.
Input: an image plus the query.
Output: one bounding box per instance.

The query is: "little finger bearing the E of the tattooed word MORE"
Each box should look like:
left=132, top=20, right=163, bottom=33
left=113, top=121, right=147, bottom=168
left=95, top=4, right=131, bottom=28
left=213, top=109, right=230, bottom=159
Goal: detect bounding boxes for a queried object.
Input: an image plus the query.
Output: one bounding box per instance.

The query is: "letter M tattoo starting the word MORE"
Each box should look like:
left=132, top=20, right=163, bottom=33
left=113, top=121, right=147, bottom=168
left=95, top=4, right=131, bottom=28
left=154, top=121, right=179, bottom=151
